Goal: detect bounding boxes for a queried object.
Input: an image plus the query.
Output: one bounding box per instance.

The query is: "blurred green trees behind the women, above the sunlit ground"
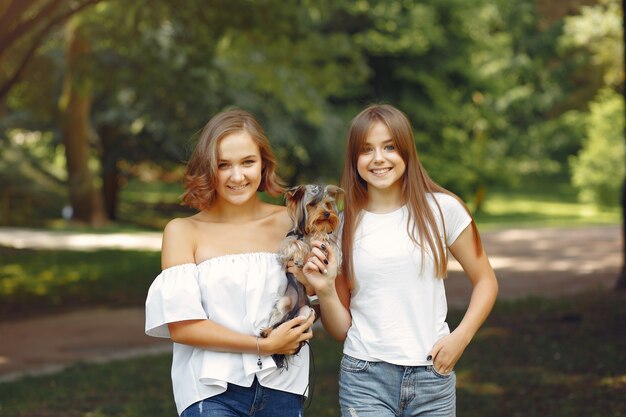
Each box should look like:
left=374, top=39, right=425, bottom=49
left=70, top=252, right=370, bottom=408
left=0, top=0, right=626, bottom=228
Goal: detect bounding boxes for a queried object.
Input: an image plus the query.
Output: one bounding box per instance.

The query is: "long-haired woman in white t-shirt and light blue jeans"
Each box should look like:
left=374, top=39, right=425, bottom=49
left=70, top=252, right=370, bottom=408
left=304, top=105, right=498, bottom=417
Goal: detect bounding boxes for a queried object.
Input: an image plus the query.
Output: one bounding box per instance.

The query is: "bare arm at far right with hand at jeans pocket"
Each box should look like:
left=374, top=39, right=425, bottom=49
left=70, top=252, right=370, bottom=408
left=429, top=225, right=498, bottom=373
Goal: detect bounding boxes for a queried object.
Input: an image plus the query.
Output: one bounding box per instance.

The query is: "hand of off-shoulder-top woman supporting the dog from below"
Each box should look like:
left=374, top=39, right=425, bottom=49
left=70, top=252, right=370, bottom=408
left=259, top=314, right=315, bottom=355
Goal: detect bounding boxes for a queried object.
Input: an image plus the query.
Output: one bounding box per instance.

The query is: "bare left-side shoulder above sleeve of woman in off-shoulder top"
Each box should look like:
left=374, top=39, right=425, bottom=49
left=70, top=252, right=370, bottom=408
left=161, top=217, right=196, bottom=269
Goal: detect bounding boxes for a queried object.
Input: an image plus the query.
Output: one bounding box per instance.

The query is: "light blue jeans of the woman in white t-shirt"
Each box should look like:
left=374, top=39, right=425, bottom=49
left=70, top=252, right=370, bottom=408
left=339, top=355, right=456, bottom=417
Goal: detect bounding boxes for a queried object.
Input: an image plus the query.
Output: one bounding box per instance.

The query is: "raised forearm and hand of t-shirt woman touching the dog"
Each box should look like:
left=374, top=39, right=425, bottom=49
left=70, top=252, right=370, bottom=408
left=302, top=242, right=352, bottom=342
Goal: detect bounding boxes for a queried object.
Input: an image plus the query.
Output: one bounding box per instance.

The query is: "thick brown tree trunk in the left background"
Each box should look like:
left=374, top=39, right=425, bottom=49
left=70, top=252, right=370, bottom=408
left=60, top=21, right=106, bottom=226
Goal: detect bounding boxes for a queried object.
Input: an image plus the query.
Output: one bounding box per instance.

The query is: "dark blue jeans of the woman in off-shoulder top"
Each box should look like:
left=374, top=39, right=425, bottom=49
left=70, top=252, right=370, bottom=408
left=180, top=378, right=304, bottom=417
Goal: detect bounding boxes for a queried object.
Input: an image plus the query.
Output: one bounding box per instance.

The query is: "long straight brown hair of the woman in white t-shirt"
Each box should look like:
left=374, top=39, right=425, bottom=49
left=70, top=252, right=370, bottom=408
left=341, top=104, right=482, bottom=285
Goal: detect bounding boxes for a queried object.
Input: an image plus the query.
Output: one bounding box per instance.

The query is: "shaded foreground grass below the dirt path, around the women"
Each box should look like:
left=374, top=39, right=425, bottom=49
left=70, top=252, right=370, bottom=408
left=0, top=292, right=626, bottom=417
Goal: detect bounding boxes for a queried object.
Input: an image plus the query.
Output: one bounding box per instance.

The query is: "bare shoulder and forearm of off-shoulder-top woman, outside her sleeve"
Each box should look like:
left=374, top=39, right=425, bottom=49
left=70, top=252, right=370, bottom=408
left=161, top=219, right=315, bottom=355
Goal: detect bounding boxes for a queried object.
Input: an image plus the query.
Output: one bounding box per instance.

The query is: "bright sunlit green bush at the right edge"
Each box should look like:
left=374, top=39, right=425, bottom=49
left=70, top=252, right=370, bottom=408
left=571, top=89, right=626, bottom=205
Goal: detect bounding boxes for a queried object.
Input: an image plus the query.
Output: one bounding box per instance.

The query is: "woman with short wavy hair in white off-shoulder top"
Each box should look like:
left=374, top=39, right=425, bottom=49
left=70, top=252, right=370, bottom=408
left=146, top=110, right=326, bottom=417
